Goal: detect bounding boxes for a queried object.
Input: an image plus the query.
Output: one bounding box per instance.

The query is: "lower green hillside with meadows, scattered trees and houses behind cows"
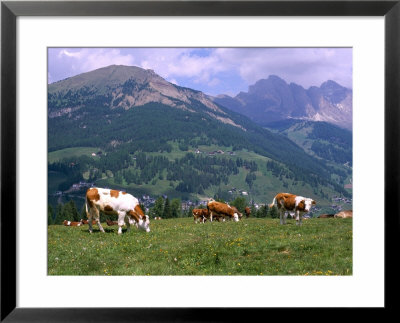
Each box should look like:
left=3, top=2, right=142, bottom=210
left=49, top=141, right=350, bottom=218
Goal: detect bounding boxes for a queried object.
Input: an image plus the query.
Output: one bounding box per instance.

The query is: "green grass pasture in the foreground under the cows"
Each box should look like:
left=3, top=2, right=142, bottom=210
left=48, top=218, right=353, bottom=275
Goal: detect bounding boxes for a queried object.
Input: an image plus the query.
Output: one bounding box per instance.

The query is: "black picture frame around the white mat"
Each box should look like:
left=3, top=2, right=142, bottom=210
left=0, top=0, right=400, bottom=322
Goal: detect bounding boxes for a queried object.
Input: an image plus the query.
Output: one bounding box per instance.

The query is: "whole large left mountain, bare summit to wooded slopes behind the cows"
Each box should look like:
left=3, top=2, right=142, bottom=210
left=48, top=66, right=351, bottom=215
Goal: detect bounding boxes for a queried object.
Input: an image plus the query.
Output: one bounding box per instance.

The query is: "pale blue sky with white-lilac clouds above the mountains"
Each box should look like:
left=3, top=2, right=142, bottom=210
left=48, top=47, right=353, bottom=96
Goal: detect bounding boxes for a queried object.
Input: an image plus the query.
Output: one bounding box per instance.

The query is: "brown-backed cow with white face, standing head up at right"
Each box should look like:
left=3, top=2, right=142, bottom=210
left=269, top=193, right=316, bottom=225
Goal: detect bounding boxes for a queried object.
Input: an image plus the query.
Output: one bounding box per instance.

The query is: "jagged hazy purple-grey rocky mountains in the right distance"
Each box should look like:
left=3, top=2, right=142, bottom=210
left=212, top=75, right=353, bottom=130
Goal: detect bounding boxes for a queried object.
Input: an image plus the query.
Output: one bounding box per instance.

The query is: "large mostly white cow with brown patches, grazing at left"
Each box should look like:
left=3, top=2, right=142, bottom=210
left=86, top=187, right=150, bottom=234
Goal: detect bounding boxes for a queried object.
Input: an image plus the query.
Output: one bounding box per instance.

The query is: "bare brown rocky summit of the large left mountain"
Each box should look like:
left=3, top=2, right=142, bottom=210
left=48, top=65, right=244, bottom=127
